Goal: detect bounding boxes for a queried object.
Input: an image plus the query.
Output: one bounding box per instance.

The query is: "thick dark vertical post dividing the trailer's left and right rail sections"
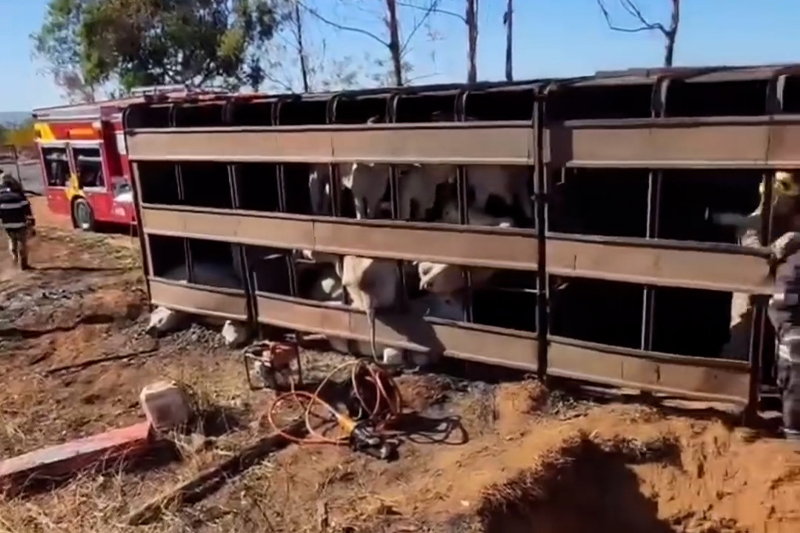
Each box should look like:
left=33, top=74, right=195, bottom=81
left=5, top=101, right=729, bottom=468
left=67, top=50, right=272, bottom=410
left=533, top=89, right=550, bottom=381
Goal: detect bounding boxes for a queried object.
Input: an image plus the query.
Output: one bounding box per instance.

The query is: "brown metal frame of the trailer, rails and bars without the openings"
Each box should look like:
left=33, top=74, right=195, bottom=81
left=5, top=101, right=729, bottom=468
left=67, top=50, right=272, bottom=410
left=125, top=66, right=800, bottom=412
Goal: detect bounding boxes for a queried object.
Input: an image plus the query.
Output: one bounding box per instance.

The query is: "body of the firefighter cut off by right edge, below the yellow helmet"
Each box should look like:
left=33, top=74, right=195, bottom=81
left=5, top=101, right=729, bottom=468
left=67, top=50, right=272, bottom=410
left=768, top=232, right=800, bottom=440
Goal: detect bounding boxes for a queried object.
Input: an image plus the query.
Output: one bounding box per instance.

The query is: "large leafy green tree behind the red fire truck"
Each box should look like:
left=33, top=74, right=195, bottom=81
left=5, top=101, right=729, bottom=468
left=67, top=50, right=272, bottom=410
left=31, top=0, right=282, bottom=94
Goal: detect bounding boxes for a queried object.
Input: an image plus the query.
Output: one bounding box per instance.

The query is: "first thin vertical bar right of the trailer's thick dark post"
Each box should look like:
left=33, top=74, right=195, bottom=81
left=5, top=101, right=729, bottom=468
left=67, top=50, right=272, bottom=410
left=640, top=77, right=670, bottom=350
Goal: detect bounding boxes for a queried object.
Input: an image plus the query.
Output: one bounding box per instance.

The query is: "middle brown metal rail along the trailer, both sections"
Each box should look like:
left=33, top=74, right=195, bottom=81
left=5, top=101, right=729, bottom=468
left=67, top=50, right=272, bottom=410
left=141, top=204, right=771, bottom=294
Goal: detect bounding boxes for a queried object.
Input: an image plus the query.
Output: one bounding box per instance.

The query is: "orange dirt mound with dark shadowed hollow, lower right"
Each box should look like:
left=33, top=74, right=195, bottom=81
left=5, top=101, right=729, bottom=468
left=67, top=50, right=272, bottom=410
left=442, top=407, right=800, bottom=533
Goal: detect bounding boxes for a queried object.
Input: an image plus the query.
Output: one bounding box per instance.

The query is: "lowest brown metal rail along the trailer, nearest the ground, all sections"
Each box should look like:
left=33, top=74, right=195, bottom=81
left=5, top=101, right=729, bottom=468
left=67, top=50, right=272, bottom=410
left=150, top=278, right=749, bottom=404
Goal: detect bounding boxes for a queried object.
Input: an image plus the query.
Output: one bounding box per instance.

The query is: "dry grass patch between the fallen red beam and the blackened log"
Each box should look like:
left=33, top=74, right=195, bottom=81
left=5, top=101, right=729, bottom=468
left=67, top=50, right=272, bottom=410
left=0, top=372, right=262, bottom=533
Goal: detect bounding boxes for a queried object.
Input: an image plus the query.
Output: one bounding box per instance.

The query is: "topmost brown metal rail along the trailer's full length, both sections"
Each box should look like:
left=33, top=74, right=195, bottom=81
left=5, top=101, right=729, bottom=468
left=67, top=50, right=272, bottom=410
left=127, top=115, right=800, bottom=168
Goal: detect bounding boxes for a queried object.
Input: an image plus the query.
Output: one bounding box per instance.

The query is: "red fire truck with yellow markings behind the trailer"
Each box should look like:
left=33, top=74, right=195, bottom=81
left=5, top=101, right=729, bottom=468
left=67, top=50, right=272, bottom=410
left=33, top=86, right=195, bottom=231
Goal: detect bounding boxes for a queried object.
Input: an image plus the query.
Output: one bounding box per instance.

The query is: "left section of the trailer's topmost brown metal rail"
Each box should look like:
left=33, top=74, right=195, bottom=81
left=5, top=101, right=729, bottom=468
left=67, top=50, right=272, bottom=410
left=127, top=121, right=534, bottom=165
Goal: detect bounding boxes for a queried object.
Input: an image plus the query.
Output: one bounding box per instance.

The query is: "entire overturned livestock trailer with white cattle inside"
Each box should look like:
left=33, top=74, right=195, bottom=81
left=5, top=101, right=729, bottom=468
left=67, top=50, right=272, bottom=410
left=124, top=66, right=800, bottom=416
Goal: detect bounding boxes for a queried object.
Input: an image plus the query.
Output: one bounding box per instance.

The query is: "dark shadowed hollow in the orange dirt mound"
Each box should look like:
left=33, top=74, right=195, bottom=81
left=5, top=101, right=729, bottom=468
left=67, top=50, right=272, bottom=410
left=477, top=431, right=674, bottom=533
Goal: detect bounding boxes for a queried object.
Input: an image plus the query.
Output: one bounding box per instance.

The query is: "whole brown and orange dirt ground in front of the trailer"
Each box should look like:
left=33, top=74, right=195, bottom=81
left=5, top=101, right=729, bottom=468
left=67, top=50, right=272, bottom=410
left=0, top=202, right=800, bottom=533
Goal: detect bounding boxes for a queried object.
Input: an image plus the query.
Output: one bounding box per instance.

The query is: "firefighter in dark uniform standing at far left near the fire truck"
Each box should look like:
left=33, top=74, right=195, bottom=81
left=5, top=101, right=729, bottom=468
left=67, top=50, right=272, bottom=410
left=0, top=172, right=36, bottom=270
